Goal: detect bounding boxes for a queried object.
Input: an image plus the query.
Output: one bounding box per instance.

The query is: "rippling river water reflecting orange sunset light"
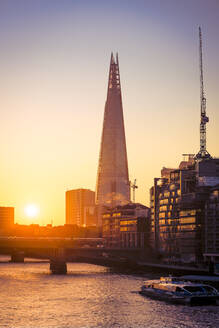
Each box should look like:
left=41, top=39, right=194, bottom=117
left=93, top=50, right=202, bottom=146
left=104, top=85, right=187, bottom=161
left=0, top=258, right=219, bottom=328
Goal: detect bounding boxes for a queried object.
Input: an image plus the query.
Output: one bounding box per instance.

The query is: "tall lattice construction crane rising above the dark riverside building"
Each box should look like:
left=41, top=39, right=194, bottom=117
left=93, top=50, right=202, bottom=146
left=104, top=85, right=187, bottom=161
left=196, top=26, right=211, bottom=160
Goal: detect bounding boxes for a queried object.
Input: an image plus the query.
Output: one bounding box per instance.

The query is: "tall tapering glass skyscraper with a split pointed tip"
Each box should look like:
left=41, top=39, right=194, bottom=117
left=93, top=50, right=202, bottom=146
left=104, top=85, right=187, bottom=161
left=96, top=54, right=130, bottom=207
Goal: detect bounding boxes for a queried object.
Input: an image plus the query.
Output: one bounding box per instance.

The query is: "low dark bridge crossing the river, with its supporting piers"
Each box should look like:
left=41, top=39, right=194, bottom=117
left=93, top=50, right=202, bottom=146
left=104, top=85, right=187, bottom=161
left=0, top=236, right=143, bottom=274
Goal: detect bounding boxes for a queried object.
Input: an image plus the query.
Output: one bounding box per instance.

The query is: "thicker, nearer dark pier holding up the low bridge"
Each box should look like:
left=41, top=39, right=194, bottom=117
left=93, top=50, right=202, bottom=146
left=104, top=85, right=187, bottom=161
left=49, top=248, right=67, bottom=274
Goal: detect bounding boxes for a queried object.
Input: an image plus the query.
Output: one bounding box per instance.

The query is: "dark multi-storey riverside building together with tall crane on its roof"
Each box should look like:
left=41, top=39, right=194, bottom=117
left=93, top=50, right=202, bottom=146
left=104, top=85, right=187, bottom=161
left=150, top=28, right=219, bottom=270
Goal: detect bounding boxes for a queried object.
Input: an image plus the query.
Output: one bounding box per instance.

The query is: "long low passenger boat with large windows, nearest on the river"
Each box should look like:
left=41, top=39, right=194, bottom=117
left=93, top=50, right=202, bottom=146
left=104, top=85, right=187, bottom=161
left=140, top=277, right=219, bottom=305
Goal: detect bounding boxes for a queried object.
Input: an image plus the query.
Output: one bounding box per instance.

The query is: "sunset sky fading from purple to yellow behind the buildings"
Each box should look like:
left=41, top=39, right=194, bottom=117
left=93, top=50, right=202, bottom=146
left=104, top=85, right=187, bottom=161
left=0, top=0, right=219, bottom=225
